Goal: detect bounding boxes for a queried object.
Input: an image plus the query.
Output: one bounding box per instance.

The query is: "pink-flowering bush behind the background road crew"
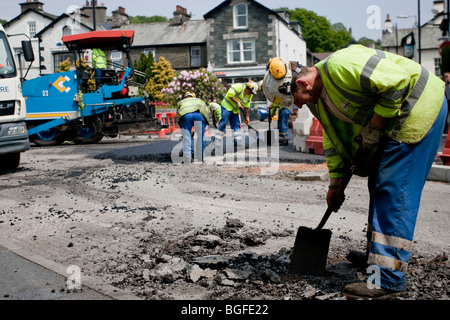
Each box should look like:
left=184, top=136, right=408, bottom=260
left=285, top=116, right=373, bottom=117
left=162, top=68, right=226, bottom=106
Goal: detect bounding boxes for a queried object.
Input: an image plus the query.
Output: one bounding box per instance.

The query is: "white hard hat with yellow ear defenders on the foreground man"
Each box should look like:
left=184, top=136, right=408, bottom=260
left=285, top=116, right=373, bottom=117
left=262, top=58, right=302, bottom=107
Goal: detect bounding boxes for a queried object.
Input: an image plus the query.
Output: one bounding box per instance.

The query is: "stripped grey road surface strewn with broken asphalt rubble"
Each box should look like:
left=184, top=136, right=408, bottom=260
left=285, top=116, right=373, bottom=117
left=0, top=142, right=450, bottom=300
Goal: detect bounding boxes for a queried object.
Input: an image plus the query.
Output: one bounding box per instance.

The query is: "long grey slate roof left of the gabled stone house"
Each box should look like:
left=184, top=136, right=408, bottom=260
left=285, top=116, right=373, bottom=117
left=120, top=20, right=207, bottom=47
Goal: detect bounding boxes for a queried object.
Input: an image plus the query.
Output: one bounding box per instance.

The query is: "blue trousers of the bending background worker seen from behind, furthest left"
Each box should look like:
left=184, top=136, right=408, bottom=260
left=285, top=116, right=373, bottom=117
left=178, top=111, right=206, bottom=160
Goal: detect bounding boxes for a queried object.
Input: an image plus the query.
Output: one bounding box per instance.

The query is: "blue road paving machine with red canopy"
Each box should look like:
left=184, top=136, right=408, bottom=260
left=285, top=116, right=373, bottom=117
left=23, top=30, right=165, bottom=146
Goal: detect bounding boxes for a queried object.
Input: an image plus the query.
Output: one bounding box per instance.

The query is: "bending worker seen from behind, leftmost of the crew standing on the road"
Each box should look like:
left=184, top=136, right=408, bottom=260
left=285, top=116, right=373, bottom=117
left=177, top=91, right=209, bottom=162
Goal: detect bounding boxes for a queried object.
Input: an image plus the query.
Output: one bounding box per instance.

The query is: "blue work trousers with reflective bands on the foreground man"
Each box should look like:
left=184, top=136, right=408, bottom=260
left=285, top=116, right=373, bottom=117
left=368, top=99, right=447, bottom=291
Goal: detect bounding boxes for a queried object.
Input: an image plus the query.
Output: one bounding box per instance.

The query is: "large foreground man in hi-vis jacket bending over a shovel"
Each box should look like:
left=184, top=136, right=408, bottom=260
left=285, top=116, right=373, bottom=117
left=263, top=45, right=447, bottom=299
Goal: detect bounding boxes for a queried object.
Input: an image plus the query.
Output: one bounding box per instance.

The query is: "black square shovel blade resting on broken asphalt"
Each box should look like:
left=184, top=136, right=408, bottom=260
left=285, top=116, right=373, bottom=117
left=289, top=227, right=332, bottom=275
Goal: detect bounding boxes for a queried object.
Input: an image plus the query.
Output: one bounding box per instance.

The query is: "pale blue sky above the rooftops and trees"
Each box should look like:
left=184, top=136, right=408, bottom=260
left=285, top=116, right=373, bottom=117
left=0, top=0, right=436, bottom=40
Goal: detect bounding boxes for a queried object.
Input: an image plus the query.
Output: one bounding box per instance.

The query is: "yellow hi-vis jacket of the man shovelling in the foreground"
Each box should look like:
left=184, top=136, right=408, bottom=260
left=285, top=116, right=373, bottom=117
left=308, top=45, right=445, bottom=178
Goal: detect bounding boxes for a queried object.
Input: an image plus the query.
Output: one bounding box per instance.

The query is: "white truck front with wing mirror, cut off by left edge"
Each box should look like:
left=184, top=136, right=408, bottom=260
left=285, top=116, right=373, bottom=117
left=0, top=25, right=34, bottom=172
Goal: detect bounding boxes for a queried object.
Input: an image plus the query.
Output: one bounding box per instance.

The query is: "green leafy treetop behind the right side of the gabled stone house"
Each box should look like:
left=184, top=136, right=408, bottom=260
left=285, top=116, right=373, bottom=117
left=290, top=8, right=353, bottom=52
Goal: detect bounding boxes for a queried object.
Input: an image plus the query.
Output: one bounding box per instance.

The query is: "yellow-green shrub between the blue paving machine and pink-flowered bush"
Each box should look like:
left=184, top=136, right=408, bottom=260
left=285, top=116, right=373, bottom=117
left=145, top=57, right=175, bottom=102
